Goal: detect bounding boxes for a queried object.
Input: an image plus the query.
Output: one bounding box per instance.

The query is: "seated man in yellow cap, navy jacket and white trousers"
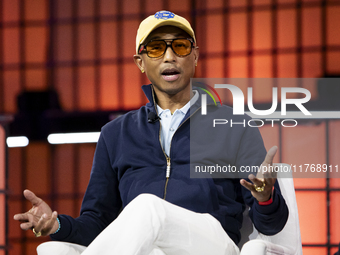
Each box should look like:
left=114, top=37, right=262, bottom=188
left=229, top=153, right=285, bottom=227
left=14, top=11, right=288, bottom=255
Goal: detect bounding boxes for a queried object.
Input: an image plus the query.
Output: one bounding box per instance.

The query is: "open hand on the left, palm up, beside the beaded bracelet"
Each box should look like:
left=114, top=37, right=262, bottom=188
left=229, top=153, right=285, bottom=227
left=14, top=189, right=59, bottom=236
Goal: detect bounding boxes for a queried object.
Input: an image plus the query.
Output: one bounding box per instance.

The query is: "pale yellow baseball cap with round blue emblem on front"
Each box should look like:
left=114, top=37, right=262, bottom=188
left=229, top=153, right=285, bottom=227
left=136, top=11, right=196, bottom=53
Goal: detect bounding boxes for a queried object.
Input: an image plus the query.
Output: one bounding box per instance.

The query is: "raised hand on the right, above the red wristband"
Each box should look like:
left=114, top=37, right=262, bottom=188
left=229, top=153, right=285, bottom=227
left=240, top=146, right=277, bottom=202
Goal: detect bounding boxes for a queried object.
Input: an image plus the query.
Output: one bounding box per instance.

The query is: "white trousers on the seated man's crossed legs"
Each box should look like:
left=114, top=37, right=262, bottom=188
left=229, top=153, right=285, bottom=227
left=82, top=194, right=239, bottom=255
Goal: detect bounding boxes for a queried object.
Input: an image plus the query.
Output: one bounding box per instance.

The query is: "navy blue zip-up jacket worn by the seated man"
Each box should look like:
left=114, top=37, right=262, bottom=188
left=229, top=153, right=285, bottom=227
left=51, top=85, right=288, bottom=246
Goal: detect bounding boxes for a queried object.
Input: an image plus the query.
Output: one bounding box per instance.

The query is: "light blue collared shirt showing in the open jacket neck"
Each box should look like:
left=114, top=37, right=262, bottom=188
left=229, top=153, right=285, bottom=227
left=157, top=90, right=198, bottom=156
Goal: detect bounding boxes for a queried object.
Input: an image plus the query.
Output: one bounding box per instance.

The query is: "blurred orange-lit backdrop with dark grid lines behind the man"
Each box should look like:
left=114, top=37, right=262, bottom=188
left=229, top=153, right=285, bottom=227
left=0, top=0, right=340, bottom=255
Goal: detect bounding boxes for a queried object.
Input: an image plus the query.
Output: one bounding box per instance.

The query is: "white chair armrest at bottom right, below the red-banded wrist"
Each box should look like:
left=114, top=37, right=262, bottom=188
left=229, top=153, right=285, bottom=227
left=240, top=239, right=294, bottom=255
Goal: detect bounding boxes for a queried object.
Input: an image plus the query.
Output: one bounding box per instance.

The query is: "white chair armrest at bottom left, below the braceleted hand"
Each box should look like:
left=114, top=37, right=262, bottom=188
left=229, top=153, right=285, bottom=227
left=37, top=241, right=86, bottom=255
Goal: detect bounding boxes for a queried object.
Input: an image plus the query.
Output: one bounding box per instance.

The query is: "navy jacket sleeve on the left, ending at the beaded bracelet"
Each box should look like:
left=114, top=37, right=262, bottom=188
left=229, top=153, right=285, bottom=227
left=51, top=132, right=122, bottom=246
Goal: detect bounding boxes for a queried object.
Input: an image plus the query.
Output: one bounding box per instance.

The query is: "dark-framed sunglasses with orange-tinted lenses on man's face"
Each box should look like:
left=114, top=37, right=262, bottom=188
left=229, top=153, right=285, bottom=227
left=138, top=38, right=195, bottom=58
